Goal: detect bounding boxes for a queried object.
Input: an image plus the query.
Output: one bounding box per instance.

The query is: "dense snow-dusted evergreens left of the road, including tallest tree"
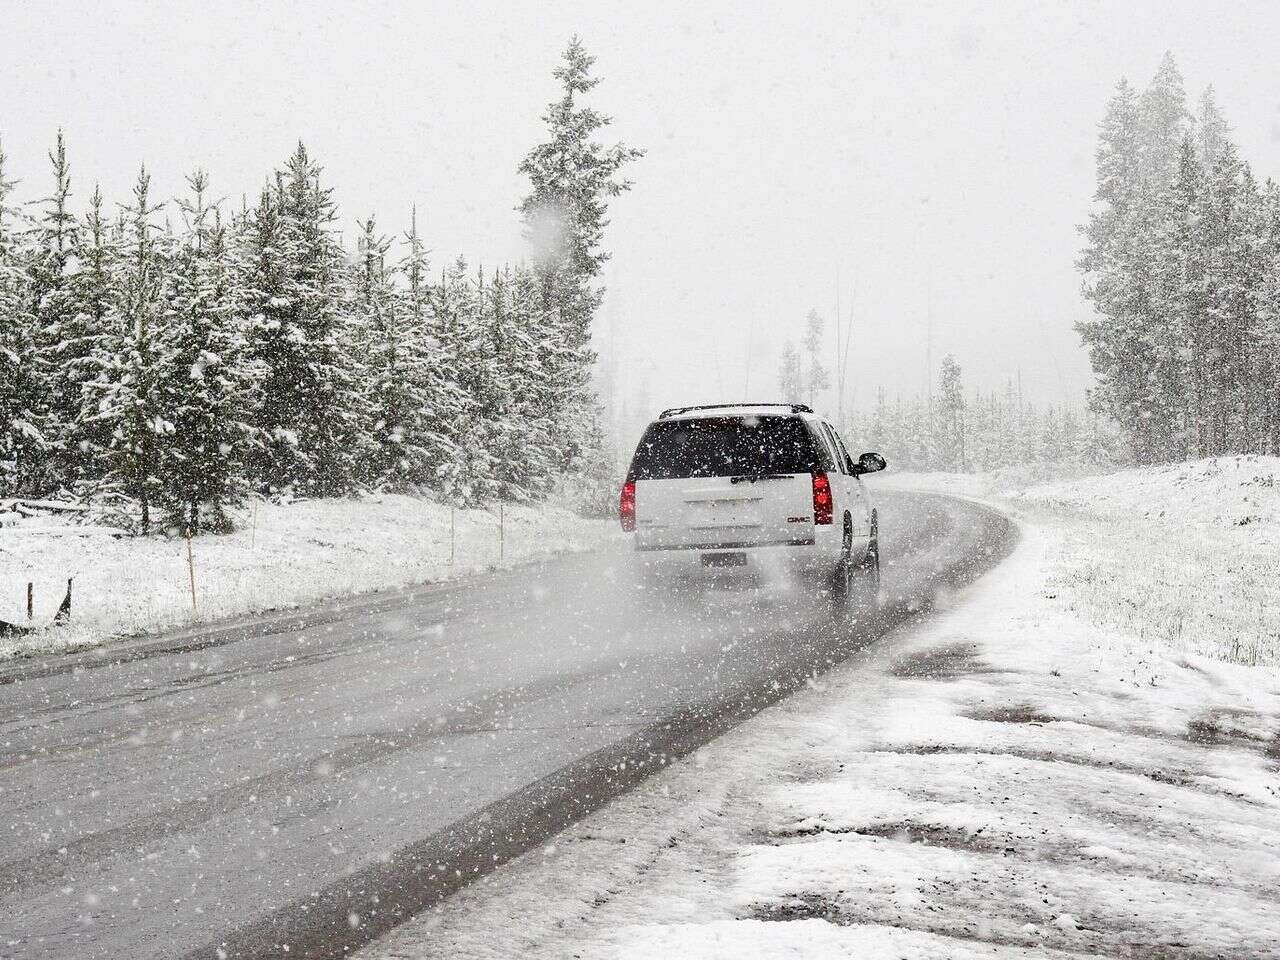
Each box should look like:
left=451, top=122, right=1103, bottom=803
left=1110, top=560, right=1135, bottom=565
left=0, top=38, right=640, bottom=532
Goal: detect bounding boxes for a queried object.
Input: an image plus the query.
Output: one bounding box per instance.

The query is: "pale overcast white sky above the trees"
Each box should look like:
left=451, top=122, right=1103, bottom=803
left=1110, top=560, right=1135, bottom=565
left=0, top=3, right=1280, bottom=435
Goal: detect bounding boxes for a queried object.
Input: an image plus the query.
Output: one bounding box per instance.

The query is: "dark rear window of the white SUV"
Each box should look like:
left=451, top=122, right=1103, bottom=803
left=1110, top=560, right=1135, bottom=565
left=630, top=416, right=827, bottom=480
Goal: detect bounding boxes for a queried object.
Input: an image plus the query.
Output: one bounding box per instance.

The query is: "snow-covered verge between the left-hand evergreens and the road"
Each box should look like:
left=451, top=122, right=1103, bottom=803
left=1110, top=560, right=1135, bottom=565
left=0, top=494, right=616, bottom=659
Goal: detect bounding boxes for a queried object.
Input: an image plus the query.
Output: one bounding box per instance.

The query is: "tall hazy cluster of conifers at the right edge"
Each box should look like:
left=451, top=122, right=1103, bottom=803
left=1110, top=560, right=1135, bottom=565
left=1079, top=54, right=1280, bottom=463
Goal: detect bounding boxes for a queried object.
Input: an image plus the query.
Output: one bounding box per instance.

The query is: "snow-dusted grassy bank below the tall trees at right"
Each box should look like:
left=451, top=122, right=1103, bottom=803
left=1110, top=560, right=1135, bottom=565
left=876, top=456, right=1280, bottom=671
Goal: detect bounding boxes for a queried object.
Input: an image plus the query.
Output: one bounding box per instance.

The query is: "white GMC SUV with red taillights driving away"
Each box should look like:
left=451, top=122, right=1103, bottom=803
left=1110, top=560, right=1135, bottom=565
left=620, top=403, right=884, bottom=602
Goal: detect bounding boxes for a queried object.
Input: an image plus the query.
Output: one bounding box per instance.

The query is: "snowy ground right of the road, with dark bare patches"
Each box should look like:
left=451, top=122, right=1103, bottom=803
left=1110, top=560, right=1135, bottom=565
left=366, top=460, right=1280, bottom=960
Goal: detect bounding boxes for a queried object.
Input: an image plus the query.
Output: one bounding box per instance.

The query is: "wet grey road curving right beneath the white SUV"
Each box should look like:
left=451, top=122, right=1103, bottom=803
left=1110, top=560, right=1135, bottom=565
left=0, top=494, right=1012, bottom=957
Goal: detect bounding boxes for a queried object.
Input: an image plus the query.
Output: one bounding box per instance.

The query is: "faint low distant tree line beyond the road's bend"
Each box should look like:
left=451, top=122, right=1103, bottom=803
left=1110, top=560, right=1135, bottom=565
left=845, top=356, right=1117, bottom=472
